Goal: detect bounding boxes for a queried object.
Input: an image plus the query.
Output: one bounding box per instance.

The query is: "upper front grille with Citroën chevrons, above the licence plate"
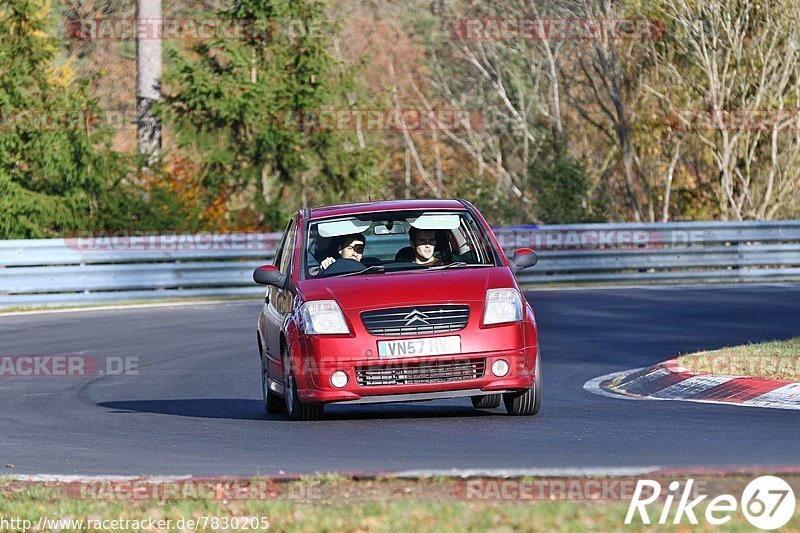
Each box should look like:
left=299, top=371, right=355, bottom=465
left=361, top=305, right=469, bottom=336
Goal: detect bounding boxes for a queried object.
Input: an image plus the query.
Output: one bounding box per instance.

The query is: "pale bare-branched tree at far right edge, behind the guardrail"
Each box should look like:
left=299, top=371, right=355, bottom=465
left=650, top=0, right=800, bottom=220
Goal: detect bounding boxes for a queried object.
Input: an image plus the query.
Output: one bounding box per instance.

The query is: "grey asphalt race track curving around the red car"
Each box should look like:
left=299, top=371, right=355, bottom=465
left=0, top=285, right=800, bottom=475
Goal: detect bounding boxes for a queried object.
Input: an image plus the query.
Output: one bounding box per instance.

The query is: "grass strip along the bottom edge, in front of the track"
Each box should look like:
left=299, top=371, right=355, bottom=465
left=0, top=476, right=800, bottom=532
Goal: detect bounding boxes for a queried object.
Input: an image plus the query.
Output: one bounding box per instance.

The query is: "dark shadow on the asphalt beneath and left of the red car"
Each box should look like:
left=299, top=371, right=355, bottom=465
left=97, top=398, right=496, bottom=422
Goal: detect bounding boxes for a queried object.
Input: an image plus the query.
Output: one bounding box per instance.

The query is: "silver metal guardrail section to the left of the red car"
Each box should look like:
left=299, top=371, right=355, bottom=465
left=0, top=233, right=280, bottom=308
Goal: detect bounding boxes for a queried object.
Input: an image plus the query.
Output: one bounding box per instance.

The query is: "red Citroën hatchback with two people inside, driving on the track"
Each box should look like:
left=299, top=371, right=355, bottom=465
left=253, top=200, right=542, bottom=420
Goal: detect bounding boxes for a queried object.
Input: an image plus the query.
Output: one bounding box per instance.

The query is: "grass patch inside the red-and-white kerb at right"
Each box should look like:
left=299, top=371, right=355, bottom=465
left=678, top=337, right=800, bottom=381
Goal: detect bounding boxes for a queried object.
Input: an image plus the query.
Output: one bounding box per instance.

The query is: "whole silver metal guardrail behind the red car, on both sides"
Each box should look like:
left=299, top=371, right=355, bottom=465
left=0, top=221, right=800, bottom=308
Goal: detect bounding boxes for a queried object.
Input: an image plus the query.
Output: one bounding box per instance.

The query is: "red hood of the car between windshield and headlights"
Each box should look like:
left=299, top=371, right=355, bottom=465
left=298, top=267, right=516, bottom=310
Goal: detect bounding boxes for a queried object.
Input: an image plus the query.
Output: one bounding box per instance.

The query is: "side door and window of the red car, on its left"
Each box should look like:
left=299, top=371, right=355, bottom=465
left=264, top=215, right=297, bottom=376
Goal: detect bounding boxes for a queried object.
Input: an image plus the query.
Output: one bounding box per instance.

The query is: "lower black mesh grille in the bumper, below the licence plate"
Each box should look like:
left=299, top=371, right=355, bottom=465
left=356, top=359, right=486, bottom=387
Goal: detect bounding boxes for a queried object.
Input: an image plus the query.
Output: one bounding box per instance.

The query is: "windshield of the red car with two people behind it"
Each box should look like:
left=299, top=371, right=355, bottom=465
left=306, top=211, right=497, bottom=278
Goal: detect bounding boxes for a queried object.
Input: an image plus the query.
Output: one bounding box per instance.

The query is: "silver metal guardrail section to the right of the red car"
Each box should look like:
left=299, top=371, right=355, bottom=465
left=496, top=220, right=800, bottom=285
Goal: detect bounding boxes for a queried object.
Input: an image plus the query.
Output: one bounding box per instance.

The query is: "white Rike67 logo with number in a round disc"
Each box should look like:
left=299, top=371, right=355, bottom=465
left=625, top=476, right=795, bottom=530
